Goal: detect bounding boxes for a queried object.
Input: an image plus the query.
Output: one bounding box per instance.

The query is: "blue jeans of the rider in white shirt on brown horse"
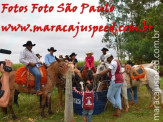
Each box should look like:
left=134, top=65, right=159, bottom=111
left=26, top=66, right=41, bottom=91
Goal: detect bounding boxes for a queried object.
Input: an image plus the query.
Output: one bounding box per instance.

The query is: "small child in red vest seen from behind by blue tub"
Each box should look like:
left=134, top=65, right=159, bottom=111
left=73, top=84, right=94, bottom=122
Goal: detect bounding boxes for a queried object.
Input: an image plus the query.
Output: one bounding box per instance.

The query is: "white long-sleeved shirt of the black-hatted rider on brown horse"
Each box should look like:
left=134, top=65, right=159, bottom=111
left=19, top=48, right=40, bottom=65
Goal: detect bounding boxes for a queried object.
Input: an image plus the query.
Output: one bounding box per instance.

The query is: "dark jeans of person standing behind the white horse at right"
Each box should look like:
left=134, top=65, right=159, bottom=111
left=127, top=87, right=138, bottom=104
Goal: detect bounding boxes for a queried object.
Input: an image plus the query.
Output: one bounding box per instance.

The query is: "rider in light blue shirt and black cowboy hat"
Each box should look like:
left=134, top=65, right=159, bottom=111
left=45, top=47, right=58, bottom=66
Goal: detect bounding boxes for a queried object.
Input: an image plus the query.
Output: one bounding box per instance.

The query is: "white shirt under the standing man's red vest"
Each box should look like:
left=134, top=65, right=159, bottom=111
left=109, top=59, right=118, bottom=81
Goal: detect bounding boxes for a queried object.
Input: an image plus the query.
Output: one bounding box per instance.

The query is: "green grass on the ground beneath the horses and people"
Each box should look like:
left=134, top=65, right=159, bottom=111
left=0, top=63, right=163, bottom=122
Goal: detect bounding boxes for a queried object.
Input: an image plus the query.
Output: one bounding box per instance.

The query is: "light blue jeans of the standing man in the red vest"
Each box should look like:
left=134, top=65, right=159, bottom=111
left=107, top=81, right=123, bottom=110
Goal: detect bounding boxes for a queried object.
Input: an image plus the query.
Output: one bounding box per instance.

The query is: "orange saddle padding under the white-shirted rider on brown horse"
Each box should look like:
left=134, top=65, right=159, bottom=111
left=15, top=66, right=47, bottom=87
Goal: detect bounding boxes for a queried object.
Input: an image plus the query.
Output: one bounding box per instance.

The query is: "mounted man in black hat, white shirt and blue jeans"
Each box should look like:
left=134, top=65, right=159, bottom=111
left=19, top=41, right=42, bottom=96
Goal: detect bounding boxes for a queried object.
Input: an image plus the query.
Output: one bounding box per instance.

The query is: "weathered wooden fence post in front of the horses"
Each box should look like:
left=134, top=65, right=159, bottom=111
left=64, top=67, right=74, bottom=122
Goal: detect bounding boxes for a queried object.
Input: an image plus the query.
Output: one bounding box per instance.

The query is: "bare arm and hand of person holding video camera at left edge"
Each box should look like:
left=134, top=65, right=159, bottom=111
left=0, top=60, right=12, bottom=107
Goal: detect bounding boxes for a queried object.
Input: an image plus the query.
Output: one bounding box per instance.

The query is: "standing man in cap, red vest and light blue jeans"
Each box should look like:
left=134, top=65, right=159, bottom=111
left=94, top=53, right=124, bottom=117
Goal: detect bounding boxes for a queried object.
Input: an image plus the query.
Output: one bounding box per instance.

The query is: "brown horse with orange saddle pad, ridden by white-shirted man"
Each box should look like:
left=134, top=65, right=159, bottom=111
left=4, top=61, right=73, bottom=119
